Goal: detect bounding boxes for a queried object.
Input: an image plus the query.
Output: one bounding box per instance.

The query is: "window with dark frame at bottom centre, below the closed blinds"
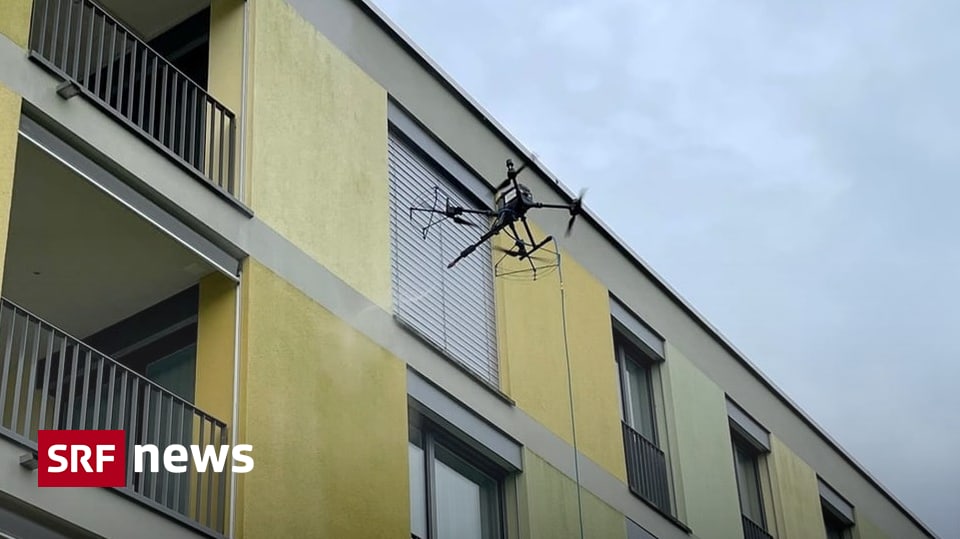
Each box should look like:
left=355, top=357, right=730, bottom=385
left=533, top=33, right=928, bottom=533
left=409, top=425, right=503, bottom=539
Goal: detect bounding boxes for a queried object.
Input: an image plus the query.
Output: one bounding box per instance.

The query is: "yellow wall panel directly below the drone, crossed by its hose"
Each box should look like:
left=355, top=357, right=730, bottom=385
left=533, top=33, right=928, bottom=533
left=497, top=226, right=626, bottom=482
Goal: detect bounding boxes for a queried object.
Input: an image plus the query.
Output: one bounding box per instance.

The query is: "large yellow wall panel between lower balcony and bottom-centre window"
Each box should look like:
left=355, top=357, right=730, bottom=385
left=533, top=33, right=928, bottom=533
left=241, top=261, right=410, bottom=539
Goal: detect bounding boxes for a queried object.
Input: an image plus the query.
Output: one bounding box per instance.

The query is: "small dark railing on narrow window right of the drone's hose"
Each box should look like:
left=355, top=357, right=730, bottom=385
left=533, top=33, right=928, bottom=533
left=623, top=423, right=673, bottom=515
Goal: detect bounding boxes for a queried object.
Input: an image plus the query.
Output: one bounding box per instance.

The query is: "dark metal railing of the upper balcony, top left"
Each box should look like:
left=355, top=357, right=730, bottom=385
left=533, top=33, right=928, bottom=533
left=30, top=0, right=240, bottom=199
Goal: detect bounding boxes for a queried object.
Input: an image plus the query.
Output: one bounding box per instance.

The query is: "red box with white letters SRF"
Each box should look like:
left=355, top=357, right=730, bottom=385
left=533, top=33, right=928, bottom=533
left=37, top=430, right=127, bottom=487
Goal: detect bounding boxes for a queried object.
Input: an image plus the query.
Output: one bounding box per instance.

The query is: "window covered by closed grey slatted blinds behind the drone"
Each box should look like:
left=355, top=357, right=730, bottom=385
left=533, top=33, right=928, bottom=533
left=389, top=132, right=499, bottom=387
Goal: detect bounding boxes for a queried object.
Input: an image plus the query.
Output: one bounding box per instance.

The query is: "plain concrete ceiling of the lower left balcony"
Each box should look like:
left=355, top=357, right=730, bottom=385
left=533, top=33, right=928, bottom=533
left=2, top=138, right=214, bottom=338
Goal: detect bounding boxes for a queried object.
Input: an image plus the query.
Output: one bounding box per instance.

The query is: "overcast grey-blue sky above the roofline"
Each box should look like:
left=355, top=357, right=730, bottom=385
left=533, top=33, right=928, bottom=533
left=376, top=0, right=960, bottom=538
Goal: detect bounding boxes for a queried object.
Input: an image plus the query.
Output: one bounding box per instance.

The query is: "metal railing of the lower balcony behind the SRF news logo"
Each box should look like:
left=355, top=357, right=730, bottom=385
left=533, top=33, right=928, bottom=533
left=0, top=299, right=229, bottom=536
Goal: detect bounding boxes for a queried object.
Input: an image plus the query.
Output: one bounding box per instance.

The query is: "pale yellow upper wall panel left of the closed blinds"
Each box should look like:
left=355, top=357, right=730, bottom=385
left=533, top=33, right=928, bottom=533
left=253, top=0, right=391, bottom=310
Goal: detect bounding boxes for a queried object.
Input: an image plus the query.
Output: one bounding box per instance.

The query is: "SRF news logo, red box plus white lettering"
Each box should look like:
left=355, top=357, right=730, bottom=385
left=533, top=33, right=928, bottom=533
left=37, top=430, right=253, bottom=487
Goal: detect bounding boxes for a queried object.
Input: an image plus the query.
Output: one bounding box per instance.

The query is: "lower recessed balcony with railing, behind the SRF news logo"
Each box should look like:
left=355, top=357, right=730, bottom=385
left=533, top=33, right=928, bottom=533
left=0, top=131, right=235, bottom=537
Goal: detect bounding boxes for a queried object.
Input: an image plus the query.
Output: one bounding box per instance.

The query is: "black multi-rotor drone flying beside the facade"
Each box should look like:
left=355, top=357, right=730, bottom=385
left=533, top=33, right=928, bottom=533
left=410, top=159, right=585, bottom=272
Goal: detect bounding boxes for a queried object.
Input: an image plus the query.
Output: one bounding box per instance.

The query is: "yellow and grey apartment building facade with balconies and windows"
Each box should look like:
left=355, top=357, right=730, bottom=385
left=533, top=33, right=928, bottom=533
left=0, top=0, right=933, bottom=539
